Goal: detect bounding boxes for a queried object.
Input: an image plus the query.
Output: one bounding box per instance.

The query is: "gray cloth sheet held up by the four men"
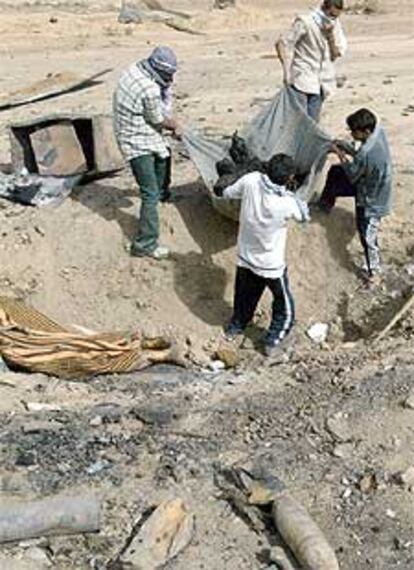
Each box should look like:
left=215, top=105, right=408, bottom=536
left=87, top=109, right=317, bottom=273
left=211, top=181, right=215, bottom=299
left=183, top=88, right=332, bottom=219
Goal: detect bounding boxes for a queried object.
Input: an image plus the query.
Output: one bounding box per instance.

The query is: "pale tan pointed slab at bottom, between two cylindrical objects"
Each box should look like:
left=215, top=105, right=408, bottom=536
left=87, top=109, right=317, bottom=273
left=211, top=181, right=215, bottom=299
left=120, top=499, right=195, bottom=570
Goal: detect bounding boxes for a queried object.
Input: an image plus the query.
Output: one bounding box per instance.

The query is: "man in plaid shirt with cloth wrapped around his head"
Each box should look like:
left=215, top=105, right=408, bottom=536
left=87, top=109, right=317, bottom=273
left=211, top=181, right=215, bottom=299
left=113, top=47, right=178, bottom=259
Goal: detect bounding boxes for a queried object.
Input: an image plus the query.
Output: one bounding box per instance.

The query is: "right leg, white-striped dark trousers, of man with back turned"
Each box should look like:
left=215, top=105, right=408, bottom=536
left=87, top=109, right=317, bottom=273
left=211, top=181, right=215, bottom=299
left=265, top=270, right=295, bottom=348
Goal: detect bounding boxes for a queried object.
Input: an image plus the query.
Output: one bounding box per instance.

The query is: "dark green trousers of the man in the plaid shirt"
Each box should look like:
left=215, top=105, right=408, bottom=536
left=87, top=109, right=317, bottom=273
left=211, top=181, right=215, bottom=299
left=130, top=154, right=167, bottom=254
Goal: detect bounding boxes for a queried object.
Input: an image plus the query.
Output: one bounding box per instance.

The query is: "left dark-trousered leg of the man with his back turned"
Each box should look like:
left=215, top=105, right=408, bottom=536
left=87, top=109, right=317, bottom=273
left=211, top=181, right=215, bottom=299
left=226, top=266, right=266, bottom=335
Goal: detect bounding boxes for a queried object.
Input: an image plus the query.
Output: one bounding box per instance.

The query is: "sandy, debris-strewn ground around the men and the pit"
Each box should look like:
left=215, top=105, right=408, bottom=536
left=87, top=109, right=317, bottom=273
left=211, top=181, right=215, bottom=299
left=0, top=0, right=414, bottom=570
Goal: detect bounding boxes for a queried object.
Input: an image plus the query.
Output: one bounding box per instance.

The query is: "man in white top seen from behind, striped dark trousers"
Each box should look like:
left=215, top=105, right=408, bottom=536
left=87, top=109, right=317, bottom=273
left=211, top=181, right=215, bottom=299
left=215, top=154, right=308, bottom=356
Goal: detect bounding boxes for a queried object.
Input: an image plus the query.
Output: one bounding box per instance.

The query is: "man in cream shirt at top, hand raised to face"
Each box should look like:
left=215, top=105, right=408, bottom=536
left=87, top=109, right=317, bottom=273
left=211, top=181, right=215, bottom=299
left=275, top=0, right=347, bottom=121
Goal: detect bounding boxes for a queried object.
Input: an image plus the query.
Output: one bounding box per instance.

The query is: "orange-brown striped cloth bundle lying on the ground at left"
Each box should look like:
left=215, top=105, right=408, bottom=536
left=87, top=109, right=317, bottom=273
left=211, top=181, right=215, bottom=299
left=0, top=297, right=182, bottom=379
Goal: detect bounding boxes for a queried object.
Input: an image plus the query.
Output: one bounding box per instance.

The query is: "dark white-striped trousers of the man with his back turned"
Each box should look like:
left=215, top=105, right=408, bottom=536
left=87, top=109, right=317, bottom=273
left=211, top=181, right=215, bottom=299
left=230, top=267, right=295, bottom=345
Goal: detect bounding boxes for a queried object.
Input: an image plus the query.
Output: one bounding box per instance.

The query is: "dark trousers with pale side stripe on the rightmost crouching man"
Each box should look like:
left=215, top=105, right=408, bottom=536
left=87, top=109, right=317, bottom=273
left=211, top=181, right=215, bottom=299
left=319, top=164, right=381, bottom=275
